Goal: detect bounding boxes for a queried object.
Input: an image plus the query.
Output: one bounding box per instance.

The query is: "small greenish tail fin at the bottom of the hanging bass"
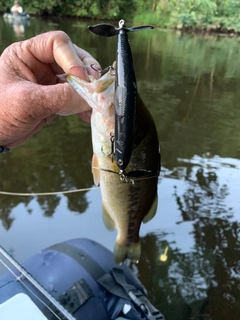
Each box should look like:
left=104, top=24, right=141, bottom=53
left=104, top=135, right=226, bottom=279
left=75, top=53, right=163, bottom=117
left=114, top=242, right=141, bottom=264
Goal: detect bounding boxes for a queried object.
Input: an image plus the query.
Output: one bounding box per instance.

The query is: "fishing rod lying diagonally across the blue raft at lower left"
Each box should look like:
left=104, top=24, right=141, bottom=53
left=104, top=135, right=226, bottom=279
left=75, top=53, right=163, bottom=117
left=0, top=246, right=76, bottom=320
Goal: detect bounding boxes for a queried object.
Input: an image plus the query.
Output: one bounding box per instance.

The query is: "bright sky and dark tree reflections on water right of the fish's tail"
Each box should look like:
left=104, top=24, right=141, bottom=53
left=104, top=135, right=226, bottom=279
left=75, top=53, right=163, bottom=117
left=138, top=156, right=240, bottom=319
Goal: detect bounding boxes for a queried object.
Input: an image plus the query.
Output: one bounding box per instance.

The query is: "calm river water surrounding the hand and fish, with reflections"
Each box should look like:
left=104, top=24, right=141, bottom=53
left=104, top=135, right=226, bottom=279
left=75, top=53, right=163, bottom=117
left=0, top=18, right=240, bottom=320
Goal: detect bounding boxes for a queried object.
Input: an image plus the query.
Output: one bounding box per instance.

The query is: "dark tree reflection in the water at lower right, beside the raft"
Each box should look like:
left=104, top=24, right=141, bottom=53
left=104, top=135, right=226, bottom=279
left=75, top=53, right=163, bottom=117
left=137, top=166, right=240, bottom=320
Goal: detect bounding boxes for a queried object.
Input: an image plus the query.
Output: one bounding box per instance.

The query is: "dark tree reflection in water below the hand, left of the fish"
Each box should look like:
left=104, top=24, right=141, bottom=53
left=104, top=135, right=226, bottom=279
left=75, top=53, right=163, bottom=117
left=0, top=117, right=93, bottom=230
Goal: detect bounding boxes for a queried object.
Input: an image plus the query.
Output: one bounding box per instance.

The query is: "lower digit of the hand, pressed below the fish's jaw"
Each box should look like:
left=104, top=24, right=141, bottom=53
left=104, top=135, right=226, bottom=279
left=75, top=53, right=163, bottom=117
left=31, top=82, right=91, bottom=119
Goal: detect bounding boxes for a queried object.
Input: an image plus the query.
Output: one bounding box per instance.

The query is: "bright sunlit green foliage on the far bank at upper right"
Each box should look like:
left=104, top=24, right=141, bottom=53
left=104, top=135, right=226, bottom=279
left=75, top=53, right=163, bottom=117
left=134, top=0, right=240, bottom=31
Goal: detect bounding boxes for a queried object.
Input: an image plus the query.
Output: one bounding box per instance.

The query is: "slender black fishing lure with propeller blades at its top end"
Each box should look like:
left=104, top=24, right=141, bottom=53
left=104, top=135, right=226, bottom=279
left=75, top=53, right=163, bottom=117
left=88, top=20, right=153, bottom=171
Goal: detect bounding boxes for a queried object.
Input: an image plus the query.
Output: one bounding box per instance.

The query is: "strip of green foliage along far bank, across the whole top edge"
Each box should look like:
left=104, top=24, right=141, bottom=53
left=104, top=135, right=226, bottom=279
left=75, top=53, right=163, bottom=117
left=0, top=0, right=240, bottom=30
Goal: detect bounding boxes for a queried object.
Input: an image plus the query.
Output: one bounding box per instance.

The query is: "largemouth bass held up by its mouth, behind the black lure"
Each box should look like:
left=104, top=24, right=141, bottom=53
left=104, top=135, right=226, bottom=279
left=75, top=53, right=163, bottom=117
left=67, top=68, right=160, bottom=263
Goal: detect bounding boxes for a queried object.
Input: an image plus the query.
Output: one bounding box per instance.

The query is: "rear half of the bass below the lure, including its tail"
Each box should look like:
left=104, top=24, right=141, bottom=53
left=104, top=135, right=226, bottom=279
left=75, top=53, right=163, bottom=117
left=100, top=162, right=157, bottom=263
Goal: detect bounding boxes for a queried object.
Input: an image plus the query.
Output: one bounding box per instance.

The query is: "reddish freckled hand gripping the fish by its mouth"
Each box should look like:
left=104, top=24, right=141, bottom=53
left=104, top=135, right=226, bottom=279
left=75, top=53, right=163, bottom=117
left=0, top=31, right=100, bottom=149
